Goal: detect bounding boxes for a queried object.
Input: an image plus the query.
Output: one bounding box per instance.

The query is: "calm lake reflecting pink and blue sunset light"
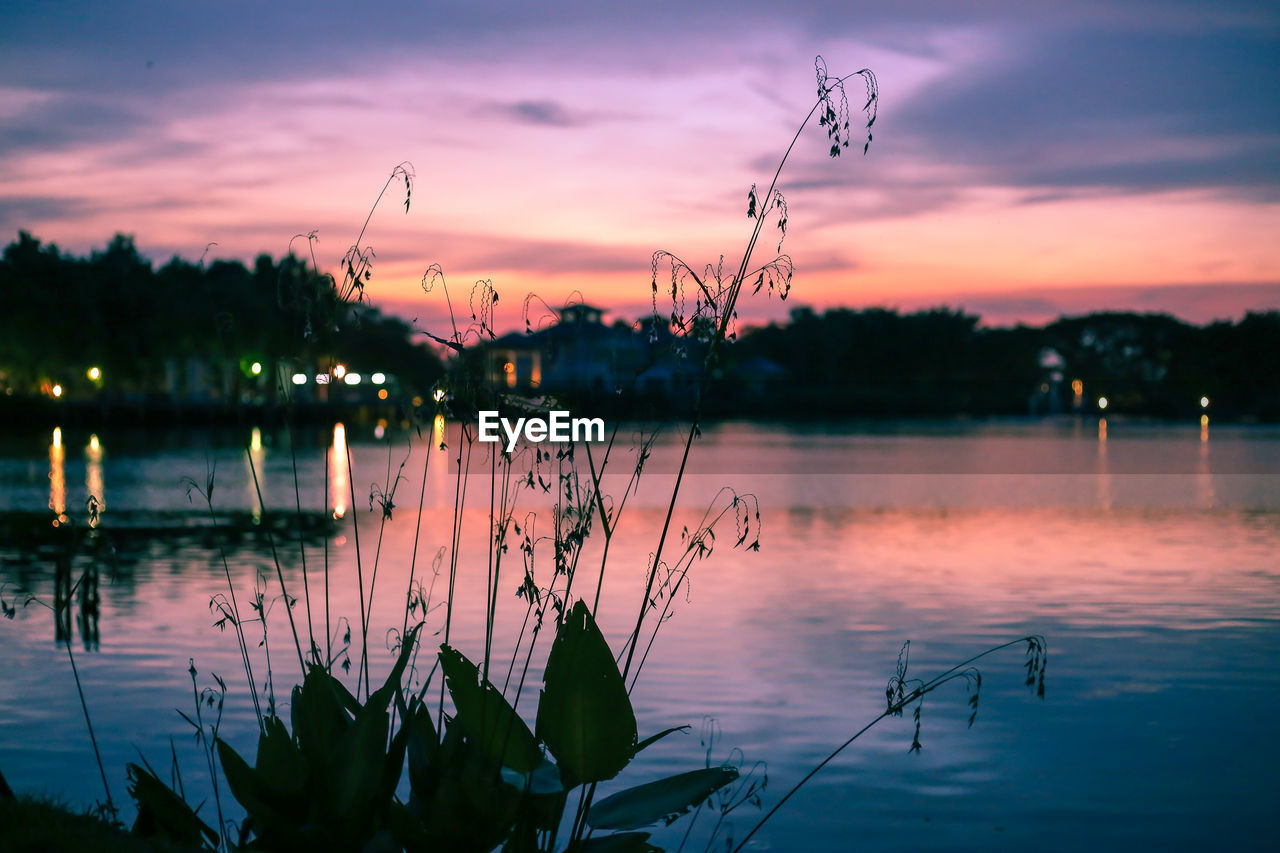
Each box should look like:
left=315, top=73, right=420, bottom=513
left=0, top=418, right=1280, bottom=850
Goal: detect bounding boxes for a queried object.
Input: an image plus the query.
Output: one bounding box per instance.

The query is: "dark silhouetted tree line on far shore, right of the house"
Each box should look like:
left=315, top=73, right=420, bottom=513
left=717, top=307, right=1280, bottom=420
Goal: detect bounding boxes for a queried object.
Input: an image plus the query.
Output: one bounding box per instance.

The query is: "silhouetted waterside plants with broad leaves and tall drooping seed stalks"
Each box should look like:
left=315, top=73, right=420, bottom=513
left=5, top=58, right=1047, bottom=853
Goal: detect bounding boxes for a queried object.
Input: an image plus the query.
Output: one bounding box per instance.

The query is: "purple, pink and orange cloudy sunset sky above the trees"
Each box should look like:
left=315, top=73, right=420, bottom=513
left=0, top=0, right=1280, bottom=327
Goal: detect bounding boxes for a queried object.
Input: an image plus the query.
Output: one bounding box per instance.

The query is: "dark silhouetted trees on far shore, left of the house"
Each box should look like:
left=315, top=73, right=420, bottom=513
left=0, top=232, right=442, bottom=394
